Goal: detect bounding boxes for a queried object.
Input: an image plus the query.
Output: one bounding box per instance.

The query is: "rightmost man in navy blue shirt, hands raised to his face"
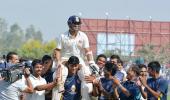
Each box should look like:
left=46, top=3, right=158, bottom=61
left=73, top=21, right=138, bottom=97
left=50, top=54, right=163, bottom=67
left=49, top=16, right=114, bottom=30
left=140, top=61, right=168, bottom=100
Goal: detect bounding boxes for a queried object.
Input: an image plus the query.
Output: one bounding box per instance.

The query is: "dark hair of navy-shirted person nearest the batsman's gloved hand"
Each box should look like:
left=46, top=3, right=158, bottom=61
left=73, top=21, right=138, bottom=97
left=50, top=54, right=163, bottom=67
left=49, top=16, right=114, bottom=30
left=104, top=61, right=117, bottom=76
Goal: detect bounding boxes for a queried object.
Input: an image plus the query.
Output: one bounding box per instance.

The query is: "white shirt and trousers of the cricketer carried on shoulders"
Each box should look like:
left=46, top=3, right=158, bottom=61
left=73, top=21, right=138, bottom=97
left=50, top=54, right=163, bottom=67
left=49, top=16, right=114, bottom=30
left=56, top=31, right=93, bottom=100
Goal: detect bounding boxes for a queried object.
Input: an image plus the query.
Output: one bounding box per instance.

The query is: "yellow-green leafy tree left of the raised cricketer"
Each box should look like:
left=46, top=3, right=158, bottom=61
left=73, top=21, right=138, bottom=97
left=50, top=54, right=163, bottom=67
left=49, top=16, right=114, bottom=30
left=18, top=39, right=56, bottom=59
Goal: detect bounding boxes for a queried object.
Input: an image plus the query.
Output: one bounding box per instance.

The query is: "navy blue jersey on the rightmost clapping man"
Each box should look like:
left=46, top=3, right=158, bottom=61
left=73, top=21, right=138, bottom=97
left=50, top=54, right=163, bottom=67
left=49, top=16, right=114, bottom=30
left=145, top=77, right=168, bottom=100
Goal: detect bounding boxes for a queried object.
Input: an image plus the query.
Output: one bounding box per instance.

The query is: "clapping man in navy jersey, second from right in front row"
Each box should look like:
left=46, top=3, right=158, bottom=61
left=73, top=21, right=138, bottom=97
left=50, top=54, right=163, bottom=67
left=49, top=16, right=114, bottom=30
left=113, top=65, right=141, bottom=100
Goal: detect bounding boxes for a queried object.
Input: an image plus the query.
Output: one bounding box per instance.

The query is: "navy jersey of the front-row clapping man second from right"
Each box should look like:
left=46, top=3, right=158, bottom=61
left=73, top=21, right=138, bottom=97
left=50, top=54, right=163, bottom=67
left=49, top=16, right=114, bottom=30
left=118, top=81, right=141, bottom=100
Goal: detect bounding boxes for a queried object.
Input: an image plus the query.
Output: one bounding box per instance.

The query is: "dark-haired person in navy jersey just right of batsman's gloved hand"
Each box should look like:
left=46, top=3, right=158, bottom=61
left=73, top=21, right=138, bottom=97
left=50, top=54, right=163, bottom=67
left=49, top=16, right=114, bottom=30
left=93, top=62, right=116, bottom=100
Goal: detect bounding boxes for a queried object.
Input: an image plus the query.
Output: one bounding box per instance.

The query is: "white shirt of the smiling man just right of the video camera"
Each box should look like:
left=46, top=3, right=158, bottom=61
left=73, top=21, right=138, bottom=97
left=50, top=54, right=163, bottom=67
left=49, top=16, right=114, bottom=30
left=25, top=75, right=47, bottom=100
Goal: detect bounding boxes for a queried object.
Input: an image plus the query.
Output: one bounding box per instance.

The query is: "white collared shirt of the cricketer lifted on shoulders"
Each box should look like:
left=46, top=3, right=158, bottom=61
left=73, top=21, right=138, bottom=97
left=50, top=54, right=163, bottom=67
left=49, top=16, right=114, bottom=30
left=57, top=31, right=89, bottom=59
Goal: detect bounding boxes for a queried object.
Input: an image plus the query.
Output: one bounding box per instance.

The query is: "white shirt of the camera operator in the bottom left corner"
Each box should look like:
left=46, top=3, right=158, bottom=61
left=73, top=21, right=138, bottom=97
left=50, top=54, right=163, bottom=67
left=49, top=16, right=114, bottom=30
left=0, top=76, right=27, bottom=100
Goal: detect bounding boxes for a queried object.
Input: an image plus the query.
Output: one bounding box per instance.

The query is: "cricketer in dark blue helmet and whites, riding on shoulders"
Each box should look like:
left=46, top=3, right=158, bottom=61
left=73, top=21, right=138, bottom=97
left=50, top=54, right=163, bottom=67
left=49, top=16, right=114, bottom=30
left=54, top=15, right=99, bottom=100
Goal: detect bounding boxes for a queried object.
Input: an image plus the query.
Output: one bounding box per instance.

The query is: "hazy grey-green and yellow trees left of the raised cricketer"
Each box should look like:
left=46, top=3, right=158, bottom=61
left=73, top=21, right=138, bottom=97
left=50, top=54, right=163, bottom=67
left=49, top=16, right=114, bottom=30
left=0, top=18, right=56, bottom=58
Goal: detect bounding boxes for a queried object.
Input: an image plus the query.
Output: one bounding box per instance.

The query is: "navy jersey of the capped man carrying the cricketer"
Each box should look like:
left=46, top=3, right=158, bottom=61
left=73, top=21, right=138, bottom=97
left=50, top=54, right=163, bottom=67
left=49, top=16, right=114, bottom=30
left=63, top=75, right=81, bottom=100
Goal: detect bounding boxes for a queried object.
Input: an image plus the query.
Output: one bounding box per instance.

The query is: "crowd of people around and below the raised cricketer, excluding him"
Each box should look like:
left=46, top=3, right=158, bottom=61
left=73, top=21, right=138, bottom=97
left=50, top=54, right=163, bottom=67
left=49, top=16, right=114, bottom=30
left=0, top=52, right=168, bottom=100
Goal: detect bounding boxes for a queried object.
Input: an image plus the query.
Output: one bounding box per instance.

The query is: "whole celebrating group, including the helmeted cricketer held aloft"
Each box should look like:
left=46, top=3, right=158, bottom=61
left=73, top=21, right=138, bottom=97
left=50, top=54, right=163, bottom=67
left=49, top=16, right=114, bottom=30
left=0, top=15, right=168, bottom=100
